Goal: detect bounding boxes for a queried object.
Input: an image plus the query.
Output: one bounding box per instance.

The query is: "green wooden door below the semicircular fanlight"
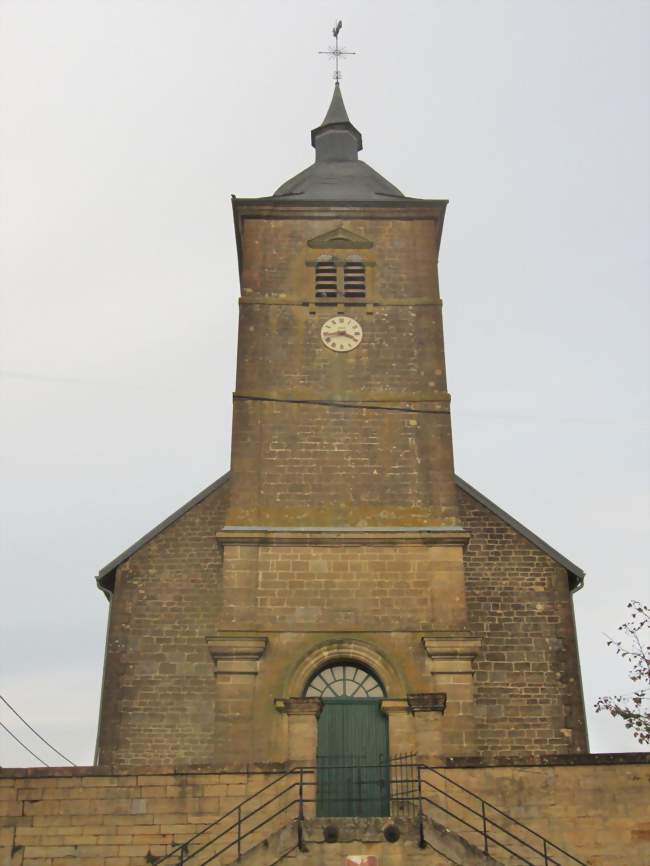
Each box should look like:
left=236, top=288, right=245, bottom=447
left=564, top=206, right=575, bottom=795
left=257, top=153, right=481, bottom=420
left=316, top=698, right=389, bottom=817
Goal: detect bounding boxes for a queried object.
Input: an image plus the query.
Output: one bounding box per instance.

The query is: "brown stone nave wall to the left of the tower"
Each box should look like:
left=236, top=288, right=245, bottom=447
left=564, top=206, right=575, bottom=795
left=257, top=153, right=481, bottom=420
left=97, top=483, right=227, bottom=768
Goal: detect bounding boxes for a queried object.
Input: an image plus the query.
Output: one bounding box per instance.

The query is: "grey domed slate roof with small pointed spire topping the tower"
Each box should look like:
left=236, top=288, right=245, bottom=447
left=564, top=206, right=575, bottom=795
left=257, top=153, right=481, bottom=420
left=273, top=81, right=404, bottom=201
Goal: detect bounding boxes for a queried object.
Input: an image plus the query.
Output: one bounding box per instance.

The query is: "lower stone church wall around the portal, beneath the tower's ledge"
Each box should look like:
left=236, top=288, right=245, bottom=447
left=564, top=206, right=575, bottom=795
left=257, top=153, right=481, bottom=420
left=93, top=472, right=586, bottom=769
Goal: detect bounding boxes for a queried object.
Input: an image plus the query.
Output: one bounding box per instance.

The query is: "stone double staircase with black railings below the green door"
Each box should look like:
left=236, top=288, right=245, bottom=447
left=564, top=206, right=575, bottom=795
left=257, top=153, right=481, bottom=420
left=155, top=763, right=587, bottom=866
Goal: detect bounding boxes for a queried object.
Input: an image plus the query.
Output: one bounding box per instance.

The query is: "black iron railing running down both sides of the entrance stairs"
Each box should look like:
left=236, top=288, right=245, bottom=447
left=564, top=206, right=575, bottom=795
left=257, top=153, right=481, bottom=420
left=156, top=754, right=587, bottom=866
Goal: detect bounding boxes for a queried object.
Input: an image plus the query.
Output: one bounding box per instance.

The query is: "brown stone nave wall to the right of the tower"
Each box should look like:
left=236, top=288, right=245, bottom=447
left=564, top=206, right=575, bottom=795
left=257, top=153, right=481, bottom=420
left=459, top=490, right=587, bottom=758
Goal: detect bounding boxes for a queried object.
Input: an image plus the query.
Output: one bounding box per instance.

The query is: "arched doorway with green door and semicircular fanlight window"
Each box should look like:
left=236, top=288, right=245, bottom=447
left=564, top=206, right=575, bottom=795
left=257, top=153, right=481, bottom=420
left=305, top=661, right=389, bottom=817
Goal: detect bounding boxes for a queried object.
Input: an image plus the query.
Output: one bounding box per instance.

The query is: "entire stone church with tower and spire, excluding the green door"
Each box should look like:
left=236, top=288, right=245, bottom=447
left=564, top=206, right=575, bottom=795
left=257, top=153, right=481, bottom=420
left=98, top=84, right=587, bottom=768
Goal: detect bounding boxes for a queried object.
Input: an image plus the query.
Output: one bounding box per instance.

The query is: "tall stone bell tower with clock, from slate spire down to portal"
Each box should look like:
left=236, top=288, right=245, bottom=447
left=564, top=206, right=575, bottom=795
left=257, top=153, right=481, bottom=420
left=217, top=81, right=478, bottom=760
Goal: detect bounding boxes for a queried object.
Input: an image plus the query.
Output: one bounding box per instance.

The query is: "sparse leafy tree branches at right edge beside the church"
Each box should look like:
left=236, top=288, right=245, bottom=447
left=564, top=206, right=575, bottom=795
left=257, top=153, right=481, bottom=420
left=594, top=601, right=650, bottom=744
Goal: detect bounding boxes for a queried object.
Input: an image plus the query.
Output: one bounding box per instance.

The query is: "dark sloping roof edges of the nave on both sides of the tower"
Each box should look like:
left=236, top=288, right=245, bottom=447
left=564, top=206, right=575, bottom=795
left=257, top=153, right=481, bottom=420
left=95, top=472, right=585, bottom=598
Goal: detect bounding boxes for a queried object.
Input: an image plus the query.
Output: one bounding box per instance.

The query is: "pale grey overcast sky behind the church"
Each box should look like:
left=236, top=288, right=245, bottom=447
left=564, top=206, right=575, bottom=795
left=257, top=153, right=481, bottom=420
left=0, top=0, right=650, bottom=766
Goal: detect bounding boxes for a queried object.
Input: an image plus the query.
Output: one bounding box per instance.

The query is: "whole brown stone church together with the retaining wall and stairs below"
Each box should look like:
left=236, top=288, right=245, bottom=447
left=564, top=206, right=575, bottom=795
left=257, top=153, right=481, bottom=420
left=3, top=64, right=650, bottom=866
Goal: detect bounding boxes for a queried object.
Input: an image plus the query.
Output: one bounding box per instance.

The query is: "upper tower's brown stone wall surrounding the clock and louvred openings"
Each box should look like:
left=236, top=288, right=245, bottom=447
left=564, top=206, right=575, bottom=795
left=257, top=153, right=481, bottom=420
left=226, top=203, right=457, bottom=527
